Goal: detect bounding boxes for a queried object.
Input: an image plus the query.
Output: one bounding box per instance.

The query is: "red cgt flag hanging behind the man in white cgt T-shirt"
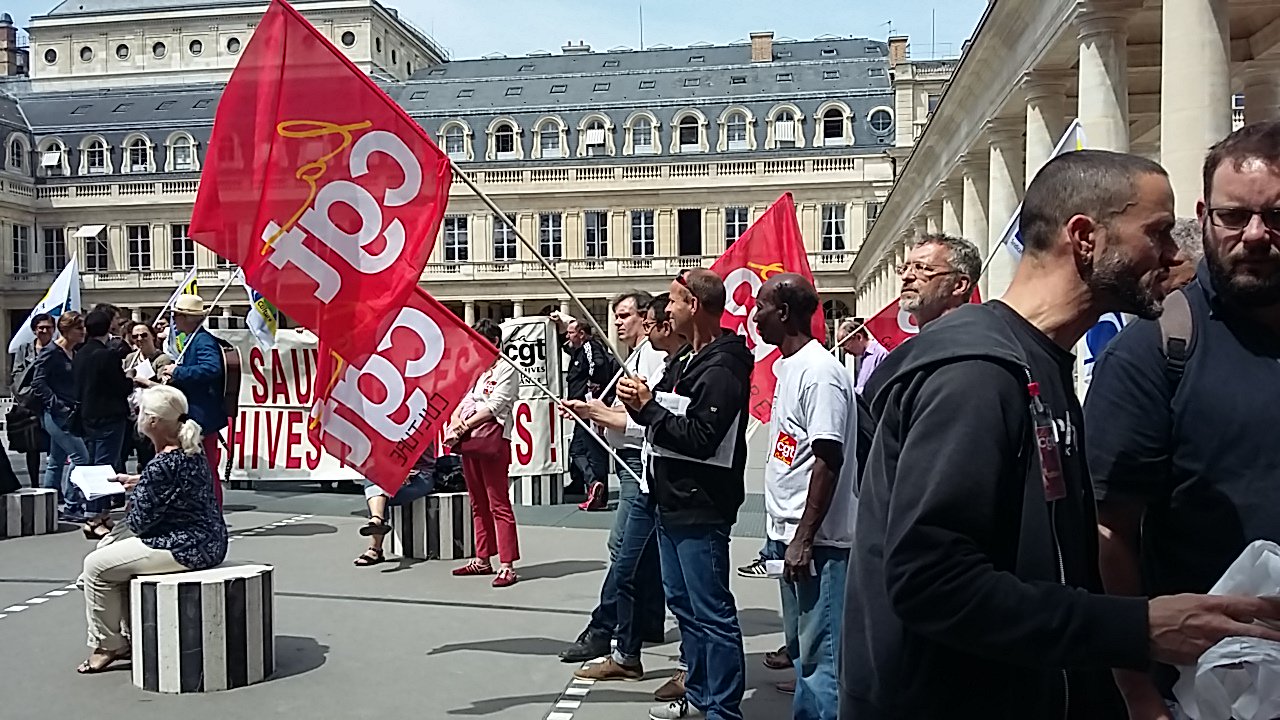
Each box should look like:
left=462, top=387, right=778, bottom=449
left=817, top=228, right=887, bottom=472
left=712, top=192, right=827, bottom=423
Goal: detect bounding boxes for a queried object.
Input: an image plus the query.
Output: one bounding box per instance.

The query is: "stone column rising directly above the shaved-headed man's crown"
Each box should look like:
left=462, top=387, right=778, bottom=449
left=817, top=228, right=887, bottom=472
left=1075, top=3, right=1132, bottom=152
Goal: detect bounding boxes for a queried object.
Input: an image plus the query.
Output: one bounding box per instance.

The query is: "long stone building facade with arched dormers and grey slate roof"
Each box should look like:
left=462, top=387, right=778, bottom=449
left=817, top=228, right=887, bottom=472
left=0, top=0, right=937, bottom=351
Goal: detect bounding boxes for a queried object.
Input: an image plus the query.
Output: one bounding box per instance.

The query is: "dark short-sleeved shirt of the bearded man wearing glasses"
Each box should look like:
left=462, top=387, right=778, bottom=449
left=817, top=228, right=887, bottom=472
left=1085, top=264, right=1280, bottom=594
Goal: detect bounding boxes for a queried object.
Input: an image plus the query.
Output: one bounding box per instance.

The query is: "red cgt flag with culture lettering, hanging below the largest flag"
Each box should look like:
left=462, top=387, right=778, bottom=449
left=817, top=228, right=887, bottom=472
left=308, top=288, right=498, bottom=496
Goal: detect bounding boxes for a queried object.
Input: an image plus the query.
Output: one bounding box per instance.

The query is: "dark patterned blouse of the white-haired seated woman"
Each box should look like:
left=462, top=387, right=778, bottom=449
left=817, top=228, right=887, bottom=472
left=125, top=450, right=227, bottom=570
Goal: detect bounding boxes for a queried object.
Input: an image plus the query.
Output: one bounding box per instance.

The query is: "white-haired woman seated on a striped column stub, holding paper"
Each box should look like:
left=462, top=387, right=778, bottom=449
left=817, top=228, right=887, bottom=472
left=77, top=386, right=227, bottom=673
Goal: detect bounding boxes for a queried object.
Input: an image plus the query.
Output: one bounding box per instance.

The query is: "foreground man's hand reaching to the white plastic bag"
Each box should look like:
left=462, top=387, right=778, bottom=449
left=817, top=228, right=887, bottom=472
left=1147, top=594, right=1280, bottom=665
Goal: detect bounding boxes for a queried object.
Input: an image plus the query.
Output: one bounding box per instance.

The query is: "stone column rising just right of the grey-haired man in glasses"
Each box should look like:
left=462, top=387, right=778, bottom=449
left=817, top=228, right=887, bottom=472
left=983, top=118, right=1025, bottom=297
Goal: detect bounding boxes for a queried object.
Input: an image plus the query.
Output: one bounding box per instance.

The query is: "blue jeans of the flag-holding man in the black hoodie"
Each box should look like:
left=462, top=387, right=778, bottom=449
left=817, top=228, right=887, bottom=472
left=658, top=514, right=746, bottom=720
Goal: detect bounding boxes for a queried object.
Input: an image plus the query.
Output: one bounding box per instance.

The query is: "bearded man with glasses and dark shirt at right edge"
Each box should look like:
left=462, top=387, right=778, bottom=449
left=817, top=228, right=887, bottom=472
left=1085, top=122, right=1280, bottom=720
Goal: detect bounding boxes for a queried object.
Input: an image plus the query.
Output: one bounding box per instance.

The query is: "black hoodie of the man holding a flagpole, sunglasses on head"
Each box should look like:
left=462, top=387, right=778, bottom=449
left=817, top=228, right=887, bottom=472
left=631, top=331, right=755, bottom=525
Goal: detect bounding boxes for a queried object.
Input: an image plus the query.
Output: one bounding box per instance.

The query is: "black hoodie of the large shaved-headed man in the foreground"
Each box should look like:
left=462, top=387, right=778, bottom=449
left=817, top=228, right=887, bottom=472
left=841, top=302, right=1148, bottom=720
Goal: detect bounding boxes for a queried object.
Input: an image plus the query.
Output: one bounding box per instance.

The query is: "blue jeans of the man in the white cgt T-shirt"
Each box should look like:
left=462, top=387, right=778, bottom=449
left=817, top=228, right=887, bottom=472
left=769, top=541, right=849, bottom=720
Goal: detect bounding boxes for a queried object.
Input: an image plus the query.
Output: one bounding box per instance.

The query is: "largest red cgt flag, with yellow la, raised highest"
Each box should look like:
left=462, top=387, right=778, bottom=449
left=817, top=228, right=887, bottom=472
left=191, top=0, right=451, bottom=360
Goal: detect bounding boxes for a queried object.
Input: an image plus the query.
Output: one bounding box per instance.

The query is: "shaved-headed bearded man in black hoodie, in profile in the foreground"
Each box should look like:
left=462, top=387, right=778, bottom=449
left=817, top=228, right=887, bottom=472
left=840, top=150, right=1280, bottom=720
